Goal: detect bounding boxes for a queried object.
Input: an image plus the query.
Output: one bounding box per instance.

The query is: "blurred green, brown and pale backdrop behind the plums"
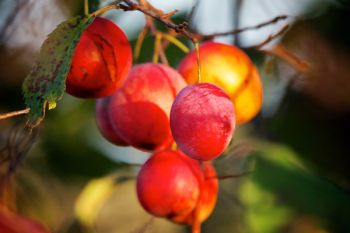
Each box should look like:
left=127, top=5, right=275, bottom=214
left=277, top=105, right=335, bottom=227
left=0, top=0, right=350, bottom=233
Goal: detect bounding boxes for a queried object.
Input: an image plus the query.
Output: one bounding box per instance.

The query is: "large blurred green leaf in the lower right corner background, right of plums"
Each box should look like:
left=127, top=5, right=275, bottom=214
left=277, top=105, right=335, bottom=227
left=240, top=144, right=350, bottom=233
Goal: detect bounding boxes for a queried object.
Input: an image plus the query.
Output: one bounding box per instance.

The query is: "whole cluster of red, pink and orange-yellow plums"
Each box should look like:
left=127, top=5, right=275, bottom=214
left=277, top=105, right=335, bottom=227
left=66, top=18, right=262, bottom=231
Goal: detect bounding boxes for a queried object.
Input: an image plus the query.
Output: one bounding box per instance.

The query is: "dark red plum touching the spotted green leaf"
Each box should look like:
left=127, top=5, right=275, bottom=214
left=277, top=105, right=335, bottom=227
left=66, top=17, right=132, bottom=98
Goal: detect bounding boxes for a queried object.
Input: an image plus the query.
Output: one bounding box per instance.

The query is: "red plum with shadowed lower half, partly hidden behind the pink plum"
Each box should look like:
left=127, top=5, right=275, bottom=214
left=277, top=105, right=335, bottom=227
left=109, top=63, right=186, bottom=151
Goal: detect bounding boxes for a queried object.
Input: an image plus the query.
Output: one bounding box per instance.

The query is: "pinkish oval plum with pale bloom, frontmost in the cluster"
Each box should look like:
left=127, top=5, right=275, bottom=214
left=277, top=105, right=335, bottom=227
left=170, top=83, right=235, bottom=161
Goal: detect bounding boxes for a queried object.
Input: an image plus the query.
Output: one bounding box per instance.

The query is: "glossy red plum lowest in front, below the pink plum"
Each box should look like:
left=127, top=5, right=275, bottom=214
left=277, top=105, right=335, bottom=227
left=137, top=151, right=200, bottom=218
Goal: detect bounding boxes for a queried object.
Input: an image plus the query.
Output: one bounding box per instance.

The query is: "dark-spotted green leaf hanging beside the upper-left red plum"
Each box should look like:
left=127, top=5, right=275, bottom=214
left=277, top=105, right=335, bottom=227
left=22, top=16, right=94, bottom=128
